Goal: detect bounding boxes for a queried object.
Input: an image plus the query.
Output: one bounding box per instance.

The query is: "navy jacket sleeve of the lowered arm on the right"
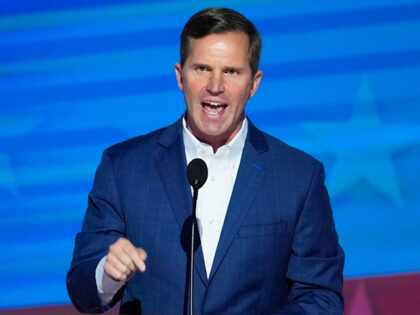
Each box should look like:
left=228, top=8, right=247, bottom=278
left=276, top=163, right=344, bottom=315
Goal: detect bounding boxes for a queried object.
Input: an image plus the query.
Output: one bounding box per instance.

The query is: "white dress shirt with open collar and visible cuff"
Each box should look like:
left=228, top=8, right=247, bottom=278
left=95, top=117, right=248, bottom=304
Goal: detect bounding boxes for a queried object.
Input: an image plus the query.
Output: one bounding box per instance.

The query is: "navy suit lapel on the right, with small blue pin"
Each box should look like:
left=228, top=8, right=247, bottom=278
left=209, top=121, right=268, bottom=282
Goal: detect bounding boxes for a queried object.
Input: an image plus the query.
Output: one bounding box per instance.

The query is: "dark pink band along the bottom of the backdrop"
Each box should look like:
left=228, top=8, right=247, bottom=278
left=0, top=273, right=420, bottom=315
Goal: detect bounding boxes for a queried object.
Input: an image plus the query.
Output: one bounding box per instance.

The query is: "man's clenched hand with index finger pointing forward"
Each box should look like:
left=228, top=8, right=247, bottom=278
left=104, top=238, right=147, bottom=281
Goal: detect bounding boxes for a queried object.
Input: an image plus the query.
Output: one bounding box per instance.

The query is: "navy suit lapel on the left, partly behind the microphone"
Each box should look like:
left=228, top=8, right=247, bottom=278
left=154, top=119, right=207, bottom=285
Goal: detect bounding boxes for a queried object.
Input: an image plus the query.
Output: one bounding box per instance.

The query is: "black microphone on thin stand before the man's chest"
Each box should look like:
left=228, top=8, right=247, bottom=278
left=187, top=159, right=208, bottom=315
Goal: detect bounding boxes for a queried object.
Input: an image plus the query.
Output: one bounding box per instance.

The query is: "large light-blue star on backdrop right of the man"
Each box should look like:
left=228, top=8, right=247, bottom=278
left=303, top=76, right=420, bottom=208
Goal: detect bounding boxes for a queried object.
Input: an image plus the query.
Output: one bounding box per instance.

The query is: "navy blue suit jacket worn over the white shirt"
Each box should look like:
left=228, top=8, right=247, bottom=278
left=67, top=120, right=344, bottom=315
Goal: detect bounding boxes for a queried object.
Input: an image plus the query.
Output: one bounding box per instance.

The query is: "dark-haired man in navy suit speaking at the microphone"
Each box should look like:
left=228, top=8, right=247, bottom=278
left=67, top=8, right=344, bottom=315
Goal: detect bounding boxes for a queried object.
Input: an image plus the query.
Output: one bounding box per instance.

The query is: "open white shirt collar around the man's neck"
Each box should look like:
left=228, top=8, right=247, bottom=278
left=182, top=115, right=248, bottom=163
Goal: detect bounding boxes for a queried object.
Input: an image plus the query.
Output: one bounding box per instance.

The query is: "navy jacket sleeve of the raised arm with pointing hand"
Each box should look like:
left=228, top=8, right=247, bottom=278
left=67, top=151, right=125, bottom=314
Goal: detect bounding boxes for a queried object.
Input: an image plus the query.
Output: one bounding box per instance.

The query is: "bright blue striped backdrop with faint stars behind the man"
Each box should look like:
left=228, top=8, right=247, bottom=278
left=0, top=0, right=420, bottom=308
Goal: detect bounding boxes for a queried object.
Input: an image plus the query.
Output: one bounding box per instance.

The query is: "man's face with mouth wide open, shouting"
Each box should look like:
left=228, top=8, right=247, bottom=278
left=175, top=32, right=262, bottom=150
